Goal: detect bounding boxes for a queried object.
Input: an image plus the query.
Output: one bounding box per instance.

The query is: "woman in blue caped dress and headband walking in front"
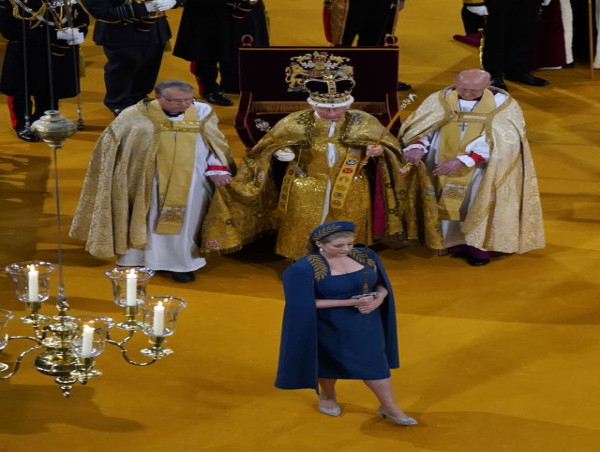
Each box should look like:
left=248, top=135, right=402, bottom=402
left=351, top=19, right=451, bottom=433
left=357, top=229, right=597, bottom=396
left=275, top=221, right=417, bottom=425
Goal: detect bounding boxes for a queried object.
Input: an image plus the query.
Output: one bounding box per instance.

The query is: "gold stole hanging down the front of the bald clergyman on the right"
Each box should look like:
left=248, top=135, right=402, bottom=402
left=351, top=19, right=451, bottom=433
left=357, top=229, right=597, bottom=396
left=438, top=89, right=496, bottom=221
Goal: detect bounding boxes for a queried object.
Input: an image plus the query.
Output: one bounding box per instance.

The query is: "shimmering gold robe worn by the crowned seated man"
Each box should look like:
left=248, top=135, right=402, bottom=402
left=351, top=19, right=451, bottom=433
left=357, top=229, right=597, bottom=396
left=202, top=110, right=434, bottom=259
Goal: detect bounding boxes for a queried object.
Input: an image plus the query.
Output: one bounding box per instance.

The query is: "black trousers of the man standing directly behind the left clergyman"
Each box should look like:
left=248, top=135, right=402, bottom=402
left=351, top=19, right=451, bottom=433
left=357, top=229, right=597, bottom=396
left=103, top=42, right=165, bottom=110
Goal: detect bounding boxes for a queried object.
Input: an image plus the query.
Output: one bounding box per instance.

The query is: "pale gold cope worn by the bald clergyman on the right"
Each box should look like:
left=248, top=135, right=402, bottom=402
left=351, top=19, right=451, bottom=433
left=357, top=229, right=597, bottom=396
left=400, top=89, right=545, bottom=253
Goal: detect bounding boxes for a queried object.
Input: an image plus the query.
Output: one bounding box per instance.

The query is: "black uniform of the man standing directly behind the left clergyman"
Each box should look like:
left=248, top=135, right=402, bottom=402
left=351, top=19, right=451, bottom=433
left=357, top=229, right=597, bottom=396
left=81, top=0, right=171, bottom=111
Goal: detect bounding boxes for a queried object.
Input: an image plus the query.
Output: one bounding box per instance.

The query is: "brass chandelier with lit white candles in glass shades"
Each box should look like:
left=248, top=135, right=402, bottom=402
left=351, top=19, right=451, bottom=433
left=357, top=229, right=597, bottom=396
left=0, top=110, right=186, bottom=397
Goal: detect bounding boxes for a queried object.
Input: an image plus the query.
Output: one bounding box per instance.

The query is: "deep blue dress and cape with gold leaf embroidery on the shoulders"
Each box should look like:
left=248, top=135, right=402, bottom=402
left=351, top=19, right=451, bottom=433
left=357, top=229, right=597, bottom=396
left=275, top=248, right=399, bottom=391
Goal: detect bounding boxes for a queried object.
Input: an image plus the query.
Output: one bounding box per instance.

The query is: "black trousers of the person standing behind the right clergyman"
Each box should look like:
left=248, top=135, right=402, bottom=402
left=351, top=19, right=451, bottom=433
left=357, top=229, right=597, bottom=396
left=481, top=0, right=542, bottom=78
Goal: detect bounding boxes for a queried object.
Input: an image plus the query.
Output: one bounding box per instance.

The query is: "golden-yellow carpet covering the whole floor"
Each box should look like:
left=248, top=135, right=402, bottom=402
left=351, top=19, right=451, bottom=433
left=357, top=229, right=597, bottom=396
left=0, top=0, right=600, bottom=452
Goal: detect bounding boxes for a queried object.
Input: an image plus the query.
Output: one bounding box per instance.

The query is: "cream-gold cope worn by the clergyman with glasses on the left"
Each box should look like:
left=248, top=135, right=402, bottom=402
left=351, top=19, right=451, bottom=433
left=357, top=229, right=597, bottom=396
left=69, top=100, right=235, bottom=257
